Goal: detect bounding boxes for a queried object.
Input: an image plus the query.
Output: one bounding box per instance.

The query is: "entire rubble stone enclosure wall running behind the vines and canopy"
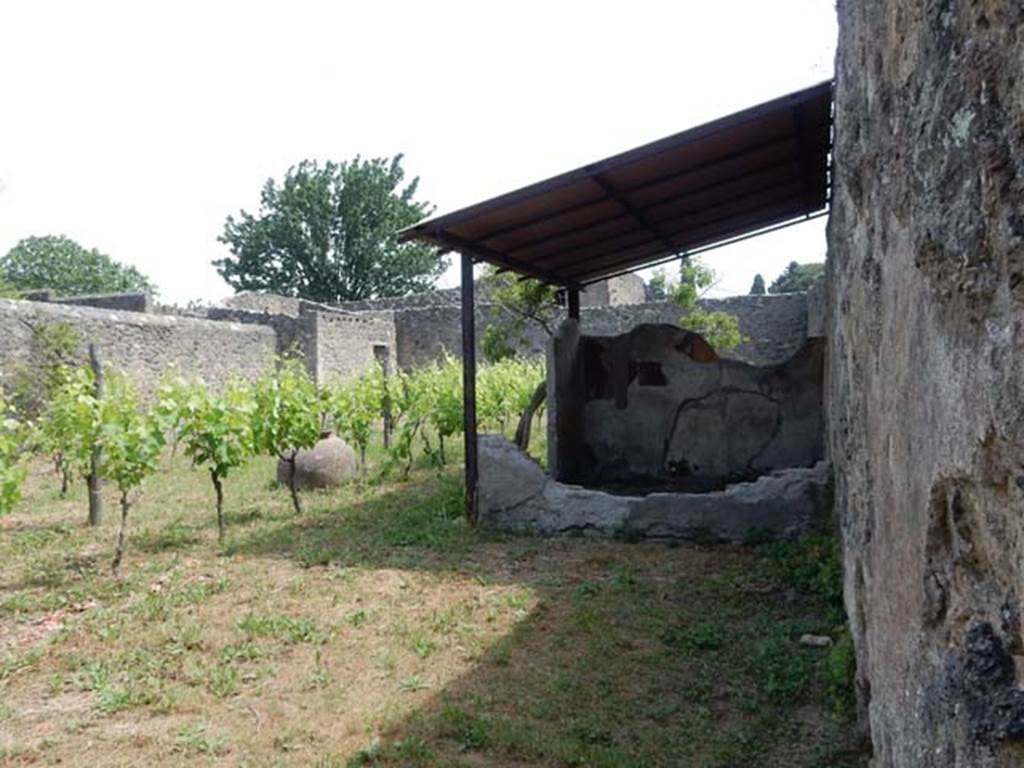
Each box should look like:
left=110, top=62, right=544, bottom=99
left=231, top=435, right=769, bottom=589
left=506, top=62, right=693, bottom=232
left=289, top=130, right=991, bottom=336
left=0, top=282, right=808, bottom=399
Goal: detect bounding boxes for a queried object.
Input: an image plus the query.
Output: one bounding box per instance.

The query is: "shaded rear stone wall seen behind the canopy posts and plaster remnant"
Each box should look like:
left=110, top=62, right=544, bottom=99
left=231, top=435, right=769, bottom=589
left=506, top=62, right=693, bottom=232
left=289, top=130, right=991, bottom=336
left=394, top=293, right=820, bottom=368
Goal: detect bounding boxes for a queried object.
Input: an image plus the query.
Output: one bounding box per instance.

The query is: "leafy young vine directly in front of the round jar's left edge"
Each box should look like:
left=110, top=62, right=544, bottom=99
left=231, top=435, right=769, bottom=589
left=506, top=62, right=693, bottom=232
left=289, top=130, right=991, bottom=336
left=252, top=359, right=323, bottom=514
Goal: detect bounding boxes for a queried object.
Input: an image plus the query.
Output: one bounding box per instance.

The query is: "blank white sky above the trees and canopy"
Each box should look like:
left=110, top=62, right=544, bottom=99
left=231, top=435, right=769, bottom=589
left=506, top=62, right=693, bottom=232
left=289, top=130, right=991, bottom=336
left=0, top=0, right=836, bottom=302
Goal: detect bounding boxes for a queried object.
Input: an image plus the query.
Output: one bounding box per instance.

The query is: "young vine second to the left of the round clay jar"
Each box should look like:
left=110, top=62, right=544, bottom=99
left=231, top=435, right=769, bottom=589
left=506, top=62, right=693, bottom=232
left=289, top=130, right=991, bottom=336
left=172, top=383, right=255, bottom=542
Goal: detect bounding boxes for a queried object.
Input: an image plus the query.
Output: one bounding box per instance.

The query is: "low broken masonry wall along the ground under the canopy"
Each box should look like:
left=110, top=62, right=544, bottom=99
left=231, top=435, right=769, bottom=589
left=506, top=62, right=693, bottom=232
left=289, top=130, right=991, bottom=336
left=479, top=435, right=829, bottom=542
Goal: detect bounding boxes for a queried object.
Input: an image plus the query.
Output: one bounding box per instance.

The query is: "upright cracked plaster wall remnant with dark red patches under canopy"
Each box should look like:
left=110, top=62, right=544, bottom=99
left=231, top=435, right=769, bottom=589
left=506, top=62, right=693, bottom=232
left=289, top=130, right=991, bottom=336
left=548, top=322, right=824, bottom=492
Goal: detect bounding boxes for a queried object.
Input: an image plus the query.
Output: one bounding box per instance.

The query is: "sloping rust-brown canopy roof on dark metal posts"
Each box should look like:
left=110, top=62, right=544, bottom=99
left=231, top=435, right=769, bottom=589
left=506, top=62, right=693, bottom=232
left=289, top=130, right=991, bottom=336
left=399, top=81, right=831, bottom=286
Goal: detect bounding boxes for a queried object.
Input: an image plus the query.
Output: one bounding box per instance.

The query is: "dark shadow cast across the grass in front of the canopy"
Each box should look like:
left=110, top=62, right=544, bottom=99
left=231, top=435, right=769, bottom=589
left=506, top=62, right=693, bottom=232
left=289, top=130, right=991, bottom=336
left=226, top=473, right=861, bottom=768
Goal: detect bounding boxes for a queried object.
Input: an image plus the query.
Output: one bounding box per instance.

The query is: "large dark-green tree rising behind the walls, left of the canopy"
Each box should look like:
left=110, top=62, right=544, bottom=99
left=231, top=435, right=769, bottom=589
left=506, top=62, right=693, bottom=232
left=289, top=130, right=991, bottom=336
left=213, top=155, right=445, bottom=302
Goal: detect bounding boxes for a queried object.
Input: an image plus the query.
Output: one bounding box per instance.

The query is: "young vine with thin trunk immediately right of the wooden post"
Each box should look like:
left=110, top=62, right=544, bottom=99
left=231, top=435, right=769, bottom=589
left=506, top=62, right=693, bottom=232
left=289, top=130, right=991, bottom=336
left=99, top=371, right=165, bottom=575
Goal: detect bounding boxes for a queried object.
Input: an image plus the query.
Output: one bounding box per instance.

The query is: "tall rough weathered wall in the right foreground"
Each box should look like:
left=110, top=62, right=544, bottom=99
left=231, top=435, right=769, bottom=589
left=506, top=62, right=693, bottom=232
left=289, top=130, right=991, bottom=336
left=827, top=0, right=1024, bottom=768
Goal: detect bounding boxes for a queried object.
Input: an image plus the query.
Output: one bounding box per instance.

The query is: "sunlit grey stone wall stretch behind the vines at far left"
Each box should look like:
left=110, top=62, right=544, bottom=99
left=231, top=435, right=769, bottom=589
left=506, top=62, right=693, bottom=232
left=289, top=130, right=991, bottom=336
left=0, top=299, right=276, bottom=393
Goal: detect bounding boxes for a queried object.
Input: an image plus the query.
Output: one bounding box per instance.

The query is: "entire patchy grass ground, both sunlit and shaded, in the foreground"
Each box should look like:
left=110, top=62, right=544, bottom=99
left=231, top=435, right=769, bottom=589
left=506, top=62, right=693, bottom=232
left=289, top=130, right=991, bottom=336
left=0, top=442, right=859, bottom=768
